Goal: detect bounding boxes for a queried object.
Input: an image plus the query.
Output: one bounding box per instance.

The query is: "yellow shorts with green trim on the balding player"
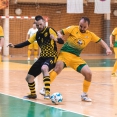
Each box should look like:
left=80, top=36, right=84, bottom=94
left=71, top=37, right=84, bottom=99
left=57, top=52, right=86, bottom=72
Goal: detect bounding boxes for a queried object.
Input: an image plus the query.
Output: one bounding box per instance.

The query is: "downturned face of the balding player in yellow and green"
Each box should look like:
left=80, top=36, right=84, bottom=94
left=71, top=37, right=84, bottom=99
left=79, top=19, right=89, bottom=33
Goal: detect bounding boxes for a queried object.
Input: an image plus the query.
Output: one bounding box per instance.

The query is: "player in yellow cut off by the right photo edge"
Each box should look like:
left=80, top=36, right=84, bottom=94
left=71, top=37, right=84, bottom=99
left=110, top=27, right=117, bottom=77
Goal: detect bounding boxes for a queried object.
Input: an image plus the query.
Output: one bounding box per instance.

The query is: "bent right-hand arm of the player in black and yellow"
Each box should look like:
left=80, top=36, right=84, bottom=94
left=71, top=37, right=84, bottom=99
left=50, top=29, right=64, bottom=44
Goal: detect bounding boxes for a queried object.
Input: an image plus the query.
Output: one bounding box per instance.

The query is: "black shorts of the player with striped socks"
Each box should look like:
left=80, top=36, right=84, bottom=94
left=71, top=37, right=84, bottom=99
left=28, top=57, right=55, bottom=77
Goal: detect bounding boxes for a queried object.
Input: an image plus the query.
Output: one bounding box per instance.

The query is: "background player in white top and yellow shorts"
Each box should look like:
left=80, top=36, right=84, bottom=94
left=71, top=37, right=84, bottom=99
left=26, top=22, right=39, bottom=61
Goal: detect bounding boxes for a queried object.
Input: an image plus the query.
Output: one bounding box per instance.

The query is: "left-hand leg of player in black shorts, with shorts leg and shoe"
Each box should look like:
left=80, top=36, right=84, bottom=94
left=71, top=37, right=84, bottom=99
left=24, top=59, right=42, bottom=99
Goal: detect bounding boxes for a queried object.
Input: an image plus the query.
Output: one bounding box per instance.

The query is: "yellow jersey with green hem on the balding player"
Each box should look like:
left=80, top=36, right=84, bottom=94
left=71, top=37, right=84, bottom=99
left=61, top=26, right=101, bottom=56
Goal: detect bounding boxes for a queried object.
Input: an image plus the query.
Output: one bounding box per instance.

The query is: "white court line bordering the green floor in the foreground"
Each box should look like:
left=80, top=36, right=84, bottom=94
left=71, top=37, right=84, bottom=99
left=0, top=92, right=93, bottom=117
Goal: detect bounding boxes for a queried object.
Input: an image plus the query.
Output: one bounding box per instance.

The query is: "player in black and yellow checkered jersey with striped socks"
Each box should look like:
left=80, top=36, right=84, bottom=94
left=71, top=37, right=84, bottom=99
left=8, top=16, right=64, bottom=99
